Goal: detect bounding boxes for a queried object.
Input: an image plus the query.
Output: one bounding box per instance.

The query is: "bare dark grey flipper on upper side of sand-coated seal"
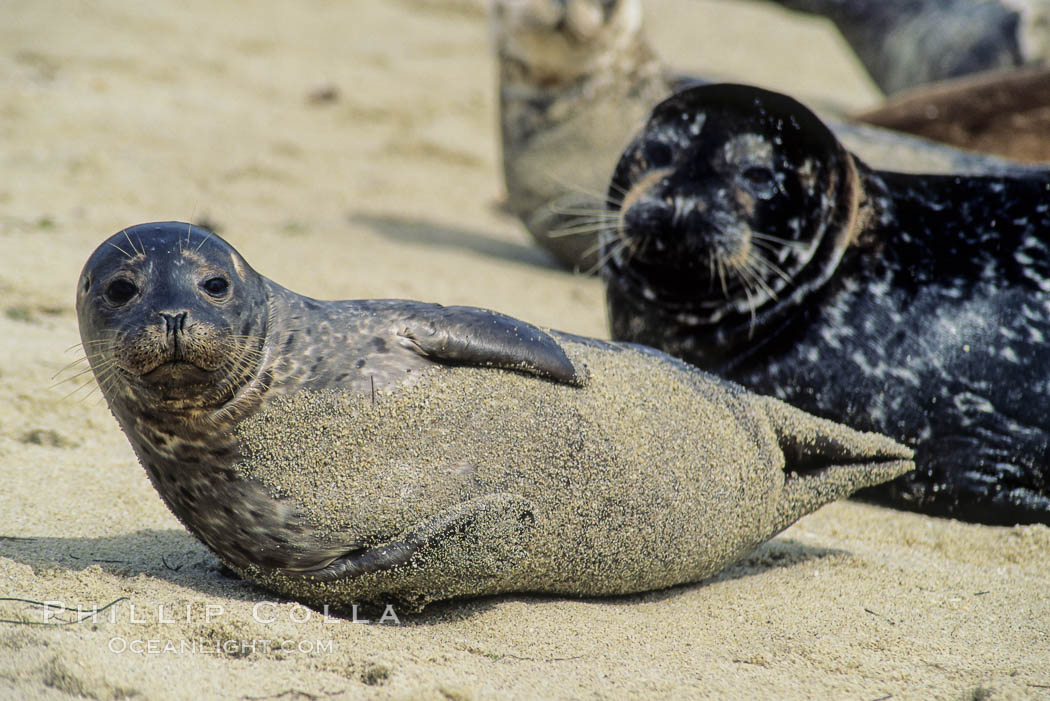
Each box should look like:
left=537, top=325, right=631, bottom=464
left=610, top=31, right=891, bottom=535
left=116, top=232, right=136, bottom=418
left=399, top=304, right=584, bottom=385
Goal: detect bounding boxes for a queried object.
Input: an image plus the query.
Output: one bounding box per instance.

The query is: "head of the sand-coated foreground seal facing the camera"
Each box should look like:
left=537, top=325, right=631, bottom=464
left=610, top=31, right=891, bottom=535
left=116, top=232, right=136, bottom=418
left=77, top=226, right=268, bottom=411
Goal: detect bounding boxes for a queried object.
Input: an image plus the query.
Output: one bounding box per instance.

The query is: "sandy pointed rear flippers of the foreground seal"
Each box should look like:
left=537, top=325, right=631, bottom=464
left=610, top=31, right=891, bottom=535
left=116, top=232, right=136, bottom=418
left=761, top=397, right=915, bottom=532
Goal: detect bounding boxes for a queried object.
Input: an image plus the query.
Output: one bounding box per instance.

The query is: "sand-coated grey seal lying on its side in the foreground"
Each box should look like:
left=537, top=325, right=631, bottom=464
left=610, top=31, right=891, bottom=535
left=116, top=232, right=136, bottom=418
left=77, top=222, right=911, bottom=604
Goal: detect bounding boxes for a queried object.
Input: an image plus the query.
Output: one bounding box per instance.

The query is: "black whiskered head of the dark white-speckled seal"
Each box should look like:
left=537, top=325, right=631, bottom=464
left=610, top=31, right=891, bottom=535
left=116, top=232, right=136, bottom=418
left=603, top=85, right=857, bottom=360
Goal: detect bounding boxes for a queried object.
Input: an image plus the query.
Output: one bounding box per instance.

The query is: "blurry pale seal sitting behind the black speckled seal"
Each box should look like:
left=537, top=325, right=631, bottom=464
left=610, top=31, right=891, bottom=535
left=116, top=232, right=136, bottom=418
left=492, top=0, right=1037, bottom=272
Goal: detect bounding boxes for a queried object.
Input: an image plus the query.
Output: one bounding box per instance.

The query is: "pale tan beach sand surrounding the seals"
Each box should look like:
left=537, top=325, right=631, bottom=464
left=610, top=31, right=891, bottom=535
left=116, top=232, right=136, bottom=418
left=0, top=0, right=1050, bottom=699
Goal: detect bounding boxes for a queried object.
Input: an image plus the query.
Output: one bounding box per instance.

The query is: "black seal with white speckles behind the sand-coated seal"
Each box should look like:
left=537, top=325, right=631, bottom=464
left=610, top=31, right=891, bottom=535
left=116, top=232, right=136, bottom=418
left=603, top=85, right=1050, bottom=524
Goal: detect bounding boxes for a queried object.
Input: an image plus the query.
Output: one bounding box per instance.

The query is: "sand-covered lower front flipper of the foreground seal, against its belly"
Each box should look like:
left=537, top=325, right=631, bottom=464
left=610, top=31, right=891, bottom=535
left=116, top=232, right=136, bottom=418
left=286, top=493, right=534, bottom=581
